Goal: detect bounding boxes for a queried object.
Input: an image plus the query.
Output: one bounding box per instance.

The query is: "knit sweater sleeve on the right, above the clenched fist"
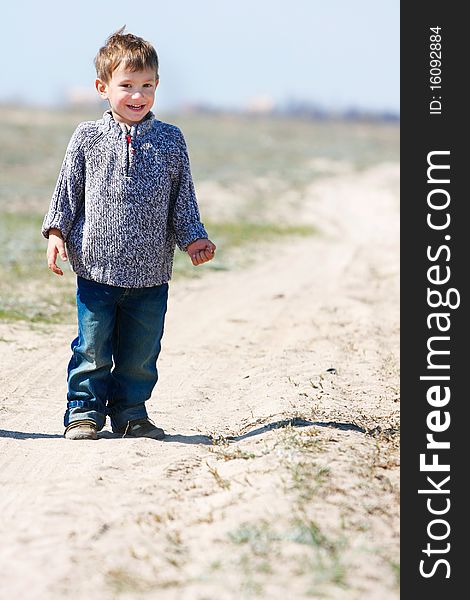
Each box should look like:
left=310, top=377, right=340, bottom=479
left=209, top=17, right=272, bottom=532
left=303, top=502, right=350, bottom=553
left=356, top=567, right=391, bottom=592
left=172, top=130, right=208, bottom=250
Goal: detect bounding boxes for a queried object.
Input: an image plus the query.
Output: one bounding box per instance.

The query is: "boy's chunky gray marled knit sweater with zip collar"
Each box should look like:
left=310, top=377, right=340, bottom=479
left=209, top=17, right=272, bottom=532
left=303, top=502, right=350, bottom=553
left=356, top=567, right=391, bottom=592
left=42, top=111, right=207, bottom=288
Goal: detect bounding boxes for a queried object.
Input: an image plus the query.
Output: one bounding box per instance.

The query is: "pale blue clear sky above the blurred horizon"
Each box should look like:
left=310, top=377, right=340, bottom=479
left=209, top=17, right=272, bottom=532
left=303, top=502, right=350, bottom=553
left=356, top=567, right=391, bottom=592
left=0, top=0, right=400, bottom=112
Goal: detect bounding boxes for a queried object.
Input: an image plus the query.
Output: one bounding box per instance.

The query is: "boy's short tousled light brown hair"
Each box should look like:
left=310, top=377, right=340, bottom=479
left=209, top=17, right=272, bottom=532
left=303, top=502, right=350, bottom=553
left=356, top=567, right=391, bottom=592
left=95, top=25, right=158, bottom=83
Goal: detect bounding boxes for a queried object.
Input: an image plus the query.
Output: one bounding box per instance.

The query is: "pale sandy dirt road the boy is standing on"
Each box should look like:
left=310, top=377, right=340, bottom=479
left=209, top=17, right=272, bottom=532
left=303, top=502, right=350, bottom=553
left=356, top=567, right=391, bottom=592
left=0, top=164, right=399, bottom=600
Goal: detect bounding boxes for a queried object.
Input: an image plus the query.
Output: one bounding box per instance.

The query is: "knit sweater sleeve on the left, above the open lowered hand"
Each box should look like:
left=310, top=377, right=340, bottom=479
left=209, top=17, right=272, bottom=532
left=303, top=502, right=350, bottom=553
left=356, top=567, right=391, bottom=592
left=42, top=124, right=85, bottom=240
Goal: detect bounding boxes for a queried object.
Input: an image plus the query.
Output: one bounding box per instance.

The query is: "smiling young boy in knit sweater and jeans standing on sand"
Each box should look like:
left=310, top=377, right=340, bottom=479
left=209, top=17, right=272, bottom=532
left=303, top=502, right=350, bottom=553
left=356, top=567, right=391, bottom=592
left=42, top=28, right=215, bottom=440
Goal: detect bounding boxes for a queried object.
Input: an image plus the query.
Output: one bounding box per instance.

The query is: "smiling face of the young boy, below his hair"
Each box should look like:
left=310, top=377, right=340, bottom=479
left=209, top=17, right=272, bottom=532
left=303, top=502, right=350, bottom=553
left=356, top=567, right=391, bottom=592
left=95, top=63, right=158, bottom=125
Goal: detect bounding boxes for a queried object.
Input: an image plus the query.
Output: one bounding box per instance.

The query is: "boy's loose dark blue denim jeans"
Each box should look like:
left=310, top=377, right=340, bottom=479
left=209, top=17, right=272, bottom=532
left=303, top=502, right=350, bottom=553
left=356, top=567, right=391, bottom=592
left=64, top=277, right=168, bottom=431
